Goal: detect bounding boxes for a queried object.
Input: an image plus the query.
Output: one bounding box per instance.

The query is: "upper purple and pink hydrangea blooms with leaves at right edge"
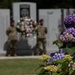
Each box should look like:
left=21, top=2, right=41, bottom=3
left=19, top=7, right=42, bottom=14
left=53, top=14, right=75, bottom=55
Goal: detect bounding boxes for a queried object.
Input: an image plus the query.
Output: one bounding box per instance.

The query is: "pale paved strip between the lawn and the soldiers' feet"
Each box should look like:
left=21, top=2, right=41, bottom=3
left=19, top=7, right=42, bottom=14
left=0, top=56, right=41, bottom=59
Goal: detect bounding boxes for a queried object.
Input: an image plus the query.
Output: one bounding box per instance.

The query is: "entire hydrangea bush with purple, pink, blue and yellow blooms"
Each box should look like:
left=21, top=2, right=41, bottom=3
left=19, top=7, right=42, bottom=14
left=38, top=14, right=75, bottom=75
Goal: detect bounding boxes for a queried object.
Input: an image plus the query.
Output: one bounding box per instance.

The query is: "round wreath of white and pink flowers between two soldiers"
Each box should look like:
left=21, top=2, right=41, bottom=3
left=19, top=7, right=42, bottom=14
left=16, top=17, right=36, bottom=37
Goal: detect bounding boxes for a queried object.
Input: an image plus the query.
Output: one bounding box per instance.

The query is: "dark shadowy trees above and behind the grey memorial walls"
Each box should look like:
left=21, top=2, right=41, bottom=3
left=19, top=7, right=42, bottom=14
left=0, top=0, right=74, bottom=9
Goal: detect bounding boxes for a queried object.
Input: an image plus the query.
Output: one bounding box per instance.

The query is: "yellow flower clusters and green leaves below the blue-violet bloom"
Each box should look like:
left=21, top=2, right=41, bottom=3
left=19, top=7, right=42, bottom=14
left=37, top=54, right=75, bottom=75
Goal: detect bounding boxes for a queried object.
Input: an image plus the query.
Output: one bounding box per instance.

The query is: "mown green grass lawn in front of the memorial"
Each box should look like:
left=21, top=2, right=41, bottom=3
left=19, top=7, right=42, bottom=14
left=0, top=58, right=42, bottom=75
